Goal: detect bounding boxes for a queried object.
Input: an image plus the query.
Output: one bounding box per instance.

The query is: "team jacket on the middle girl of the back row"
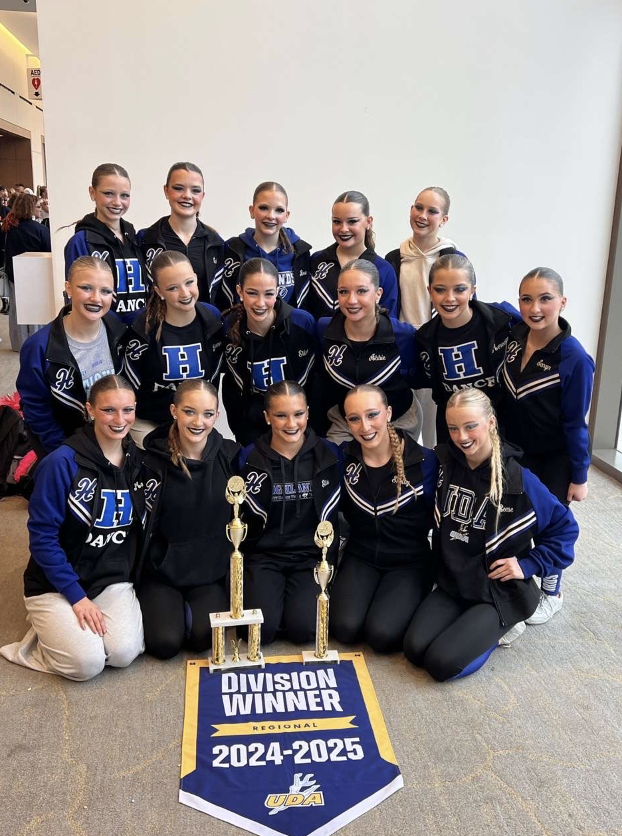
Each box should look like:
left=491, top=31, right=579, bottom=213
left=223, top=227, right=311, bottom=308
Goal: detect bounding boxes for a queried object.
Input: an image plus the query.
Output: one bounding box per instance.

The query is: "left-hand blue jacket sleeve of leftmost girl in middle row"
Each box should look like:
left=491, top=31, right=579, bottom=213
left=17, top=329, right=65, bottom=453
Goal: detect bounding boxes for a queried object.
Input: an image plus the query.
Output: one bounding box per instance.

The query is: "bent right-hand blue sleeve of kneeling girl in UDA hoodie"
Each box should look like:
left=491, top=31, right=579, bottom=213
left=518, top=468, right=579, bottom=578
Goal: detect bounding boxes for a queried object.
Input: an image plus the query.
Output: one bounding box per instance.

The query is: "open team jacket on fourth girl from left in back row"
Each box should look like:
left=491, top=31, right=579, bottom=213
left=303, top=244, right=398, bottom=319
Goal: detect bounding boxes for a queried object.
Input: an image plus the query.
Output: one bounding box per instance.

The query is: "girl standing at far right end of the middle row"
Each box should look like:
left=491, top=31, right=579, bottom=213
left=500, top=267, right=594, bottom=624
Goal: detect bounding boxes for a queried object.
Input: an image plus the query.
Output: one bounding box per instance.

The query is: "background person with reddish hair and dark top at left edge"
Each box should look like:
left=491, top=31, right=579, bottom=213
left=2, top=193, right=52, bottom=351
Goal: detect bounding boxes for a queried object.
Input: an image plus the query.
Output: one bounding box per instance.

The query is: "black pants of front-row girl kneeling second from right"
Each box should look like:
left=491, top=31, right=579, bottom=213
left=330, top=554, right=432, bottom=653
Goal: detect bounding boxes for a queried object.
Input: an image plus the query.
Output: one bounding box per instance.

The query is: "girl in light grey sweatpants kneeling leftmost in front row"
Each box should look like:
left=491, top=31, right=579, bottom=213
left=0, top=375, right=144, bottom=681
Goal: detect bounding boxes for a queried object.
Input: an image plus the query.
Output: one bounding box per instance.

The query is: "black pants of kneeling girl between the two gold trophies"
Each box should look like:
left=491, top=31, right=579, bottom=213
left=244, top=556, right=320, bottom=644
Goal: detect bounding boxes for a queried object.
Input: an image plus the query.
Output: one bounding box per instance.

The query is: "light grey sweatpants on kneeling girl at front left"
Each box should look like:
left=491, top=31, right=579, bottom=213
left=0, top=583, right=145, bottom=681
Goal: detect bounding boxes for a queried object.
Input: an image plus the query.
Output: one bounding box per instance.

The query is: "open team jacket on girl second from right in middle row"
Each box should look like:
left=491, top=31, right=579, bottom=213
left=415, top=299, right=520, bottom=407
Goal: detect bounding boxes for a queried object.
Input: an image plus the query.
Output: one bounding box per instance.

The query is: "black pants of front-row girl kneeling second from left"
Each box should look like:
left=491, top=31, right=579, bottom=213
left=137, top=578, right=229, bottom=659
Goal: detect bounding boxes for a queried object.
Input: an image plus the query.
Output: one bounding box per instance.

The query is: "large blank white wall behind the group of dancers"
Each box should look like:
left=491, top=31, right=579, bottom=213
left=38, top=0, right=622, bottom=353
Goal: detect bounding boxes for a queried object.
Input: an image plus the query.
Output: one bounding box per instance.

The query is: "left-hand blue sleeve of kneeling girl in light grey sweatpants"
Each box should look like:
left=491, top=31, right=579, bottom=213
left=28, top=447, right=86, bottom=606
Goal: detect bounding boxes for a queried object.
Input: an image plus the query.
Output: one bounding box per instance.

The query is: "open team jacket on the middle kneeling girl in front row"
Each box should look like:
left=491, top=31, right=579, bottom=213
left=239, top=429, right=341, bottom=562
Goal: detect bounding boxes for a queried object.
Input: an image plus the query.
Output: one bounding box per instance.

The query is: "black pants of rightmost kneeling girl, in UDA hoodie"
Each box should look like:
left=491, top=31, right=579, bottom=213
left=404, top=587, right=513, bottom=682
